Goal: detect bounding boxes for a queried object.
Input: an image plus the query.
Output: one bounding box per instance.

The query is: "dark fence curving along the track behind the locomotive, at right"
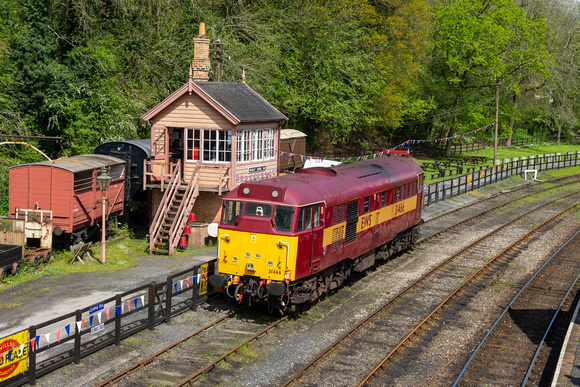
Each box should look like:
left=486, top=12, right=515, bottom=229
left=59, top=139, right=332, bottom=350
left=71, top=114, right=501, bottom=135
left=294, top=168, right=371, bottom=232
left=423, top=151, right=580, bottom=207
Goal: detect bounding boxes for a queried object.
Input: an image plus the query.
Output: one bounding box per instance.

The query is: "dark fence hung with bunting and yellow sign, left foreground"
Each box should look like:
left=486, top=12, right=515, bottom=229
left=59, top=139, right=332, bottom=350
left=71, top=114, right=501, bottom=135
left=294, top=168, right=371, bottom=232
left=0, top=260, right=215, bottom=387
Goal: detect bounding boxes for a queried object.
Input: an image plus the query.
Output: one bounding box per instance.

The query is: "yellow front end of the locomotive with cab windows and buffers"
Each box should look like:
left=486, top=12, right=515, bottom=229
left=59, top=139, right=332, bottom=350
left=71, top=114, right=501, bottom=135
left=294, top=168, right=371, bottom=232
left=209, top=200, right=298, bottom=307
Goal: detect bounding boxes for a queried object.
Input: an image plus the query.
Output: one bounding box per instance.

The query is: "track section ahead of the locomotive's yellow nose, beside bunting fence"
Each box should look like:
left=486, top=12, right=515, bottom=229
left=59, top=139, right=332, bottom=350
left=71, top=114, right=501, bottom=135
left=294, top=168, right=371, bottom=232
left=98, top=308, right=287, bottom=387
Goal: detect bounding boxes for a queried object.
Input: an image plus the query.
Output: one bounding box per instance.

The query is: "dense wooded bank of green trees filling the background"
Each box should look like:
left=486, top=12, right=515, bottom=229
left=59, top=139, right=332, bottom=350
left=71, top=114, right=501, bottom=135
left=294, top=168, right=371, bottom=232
left=0, top=0, right=580, bottom=162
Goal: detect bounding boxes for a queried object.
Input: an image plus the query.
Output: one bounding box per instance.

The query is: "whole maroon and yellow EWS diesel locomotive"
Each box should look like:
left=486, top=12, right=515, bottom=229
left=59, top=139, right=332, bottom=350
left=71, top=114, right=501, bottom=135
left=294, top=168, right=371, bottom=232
left=209, top=157, right=423, bottom=312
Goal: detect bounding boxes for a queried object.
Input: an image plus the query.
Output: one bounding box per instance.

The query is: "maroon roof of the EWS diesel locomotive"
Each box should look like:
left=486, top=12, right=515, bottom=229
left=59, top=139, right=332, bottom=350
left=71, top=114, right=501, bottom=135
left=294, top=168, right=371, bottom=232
left=228, top=157, right=423, bottom=206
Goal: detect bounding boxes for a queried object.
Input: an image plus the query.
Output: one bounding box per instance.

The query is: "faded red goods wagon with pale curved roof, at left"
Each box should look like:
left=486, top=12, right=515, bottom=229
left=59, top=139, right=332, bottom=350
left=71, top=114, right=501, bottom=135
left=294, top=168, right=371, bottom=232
left=9, top=155, right=125, bottom=236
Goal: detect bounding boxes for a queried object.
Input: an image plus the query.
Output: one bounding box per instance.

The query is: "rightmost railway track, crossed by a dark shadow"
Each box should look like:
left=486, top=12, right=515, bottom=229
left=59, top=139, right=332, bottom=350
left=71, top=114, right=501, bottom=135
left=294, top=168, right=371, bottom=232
left=454, top=232, right=580, bottom=386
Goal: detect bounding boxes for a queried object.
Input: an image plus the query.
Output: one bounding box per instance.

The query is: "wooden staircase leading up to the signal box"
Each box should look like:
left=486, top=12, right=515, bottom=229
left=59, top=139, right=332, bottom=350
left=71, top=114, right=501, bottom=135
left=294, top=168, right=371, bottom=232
left=149, top=162, right=199, bottom=254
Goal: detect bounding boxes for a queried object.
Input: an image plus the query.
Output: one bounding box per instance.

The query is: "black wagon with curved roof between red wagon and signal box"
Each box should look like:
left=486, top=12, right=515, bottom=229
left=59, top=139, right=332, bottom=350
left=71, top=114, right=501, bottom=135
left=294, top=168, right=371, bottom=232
left=93, top=138, right=151, bottom=203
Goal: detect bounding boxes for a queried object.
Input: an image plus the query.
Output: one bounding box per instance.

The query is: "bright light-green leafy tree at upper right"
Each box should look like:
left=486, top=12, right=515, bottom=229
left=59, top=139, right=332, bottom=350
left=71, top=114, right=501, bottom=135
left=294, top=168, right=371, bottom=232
left=432, top=0, right=549, bottom=158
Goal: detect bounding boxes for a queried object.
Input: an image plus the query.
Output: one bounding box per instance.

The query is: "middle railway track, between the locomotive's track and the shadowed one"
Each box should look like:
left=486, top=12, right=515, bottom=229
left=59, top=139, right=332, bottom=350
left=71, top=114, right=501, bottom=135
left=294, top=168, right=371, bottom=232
left=282, top=186, right=578, bottom=386
